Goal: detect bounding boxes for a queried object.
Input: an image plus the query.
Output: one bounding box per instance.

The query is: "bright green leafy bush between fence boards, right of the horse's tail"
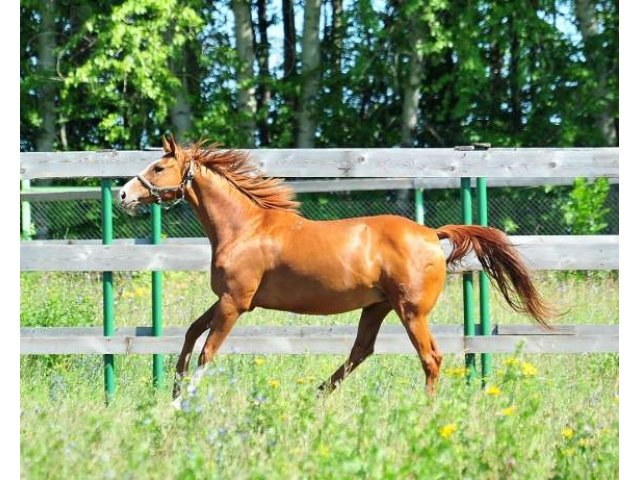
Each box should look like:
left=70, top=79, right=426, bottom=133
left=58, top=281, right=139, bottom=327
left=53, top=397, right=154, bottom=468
left=562, top=178, right=610, bottom=235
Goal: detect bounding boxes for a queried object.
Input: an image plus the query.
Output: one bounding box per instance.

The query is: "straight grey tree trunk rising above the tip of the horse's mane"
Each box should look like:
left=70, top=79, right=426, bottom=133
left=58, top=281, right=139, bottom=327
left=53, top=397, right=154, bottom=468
left=296, top=0, right=321, bottom=148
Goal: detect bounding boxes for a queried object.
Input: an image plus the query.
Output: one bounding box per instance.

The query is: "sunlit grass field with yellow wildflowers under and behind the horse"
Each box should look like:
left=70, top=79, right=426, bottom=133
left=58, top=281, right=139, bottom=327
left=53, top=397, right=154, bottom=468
left=20, top=272, right=618, bottom=479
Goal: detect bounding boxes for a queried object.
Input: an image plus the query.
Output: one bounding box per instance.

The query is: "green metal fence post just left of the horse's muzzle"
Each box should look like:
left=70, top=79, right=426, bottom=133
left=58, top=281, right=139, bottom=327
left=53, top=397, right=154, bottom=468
left=101, top=179, right=116, bottom=404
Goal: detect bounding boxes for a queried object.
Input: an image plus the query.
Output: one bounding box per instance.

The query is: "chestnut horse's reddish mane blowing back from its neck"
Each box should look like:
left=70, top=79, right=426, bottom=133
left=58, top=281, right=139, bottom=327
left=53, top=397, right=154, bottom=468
left=190, top=141, right=300, bottom=212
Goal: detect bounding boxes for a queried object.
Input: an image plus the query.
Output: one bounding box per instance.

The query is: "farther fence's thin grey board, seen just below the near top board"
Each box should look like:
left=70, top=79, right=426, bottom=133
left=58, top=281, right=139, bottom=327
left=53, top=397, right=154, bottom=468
left=20, top=177, right=619, bottom=202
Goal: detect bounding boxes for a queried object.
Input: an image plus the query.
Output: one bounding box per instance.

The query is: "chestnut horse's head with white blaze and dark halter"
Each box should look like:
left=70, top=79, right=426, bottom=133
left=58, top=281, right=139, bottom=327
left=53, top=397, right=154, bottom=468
left=119, top=136, right=194, bottom=213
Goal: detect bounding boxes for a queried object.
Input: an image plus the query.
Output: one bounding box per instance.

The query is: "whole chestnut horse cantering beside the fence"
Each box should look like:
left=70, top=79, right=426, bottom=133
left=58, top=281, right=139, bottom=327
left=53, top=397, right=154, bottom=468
left=120, top=137, right=552, bottom=398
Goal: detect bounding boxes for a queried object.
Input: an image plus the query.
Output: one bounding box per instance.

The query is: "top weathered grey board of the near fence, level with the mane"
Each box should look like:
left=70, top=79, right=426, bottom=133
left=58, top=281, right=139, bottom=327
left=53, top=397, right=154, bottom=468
left=20, top=148, right=619, bottom=179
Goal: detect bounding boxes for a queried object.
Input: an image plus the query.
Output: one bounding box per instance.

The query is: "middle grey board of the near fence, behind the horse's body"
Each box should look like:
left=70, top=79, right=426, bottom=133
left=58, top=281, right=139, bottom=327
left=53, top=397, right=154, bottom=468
left=20, top=235, right=618, bottom=273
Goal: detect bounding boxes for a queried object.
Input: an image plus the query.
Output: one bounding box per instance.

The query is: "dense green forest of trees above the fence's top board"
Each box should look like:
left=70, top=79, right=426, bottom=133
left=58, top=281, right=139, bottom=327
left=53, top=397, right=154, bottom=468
left=20, top=0, right=619, bottom=151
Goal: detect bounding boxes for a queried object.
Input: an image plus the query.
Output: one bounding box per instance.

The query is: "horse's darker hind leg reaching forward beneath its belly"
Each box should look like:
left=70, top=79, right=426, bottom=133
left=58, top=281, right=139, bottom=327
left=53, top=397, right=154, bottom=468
left=319, top=302, right=391, bottom=392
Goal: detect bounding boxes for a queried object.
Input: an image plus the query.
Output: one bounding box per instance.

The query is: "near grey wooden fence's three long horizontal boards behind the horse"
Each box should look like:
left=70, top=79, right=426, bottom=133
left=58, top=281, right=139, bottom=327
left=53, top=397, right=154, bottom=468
left=20, top=148, right=618, bottom=362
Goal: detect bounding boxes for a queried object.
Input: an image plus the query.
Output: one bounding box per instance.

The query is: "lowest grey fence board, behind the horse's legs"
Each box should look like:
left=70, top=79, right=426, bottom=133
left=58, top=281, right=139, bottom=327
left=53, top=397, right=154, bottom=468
left=20, top=325, right=618, bottom=355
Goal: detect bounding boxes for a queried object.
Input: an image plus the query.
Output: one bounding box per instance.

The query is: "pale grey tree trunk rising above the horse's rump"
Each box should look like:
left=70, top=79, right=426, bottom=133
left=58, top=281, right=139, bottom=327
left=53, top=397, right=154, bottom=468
left=400, top=19, right=425, bottom=147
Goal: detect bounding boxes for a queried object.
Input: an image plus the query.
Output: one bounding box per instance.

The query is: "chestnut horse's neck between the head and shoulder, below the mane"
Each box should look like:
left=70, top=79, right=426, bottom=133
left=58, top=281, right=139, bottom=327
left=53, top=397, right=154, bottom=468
left=187, top=169, right=264, bottom=253
